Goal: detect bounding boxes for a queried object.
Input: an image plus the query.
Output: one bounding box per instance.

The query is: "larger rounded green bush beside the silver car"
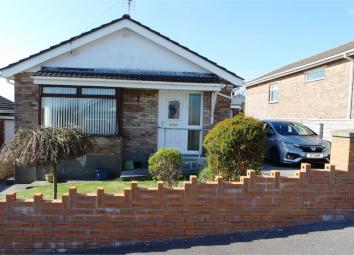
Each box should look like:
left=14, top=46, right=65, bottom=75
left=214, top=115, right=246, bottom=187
left=204, top=114, right=266, bottom=180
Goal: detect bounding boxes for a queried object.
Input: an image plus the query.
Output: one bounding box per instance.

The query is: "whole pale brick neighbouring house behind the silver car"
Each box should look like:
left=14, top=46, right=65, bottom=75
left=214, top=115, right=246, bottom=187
left=245, top=42, right=354, bottom=140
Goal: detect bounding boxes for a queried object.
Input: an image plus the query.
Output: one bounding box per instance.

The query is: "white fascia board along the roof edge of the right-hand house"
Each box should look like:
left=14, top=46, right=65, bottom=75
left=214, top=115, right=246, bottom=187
left=245, top=49, right=354, bottom=88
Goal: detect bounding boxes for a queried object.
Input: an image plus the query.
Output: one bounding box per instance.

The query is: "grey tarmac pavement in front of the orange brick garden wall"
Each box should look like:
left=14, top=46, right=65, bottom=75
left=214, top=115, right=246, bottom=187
left=70, top=220, right=354, bottom=255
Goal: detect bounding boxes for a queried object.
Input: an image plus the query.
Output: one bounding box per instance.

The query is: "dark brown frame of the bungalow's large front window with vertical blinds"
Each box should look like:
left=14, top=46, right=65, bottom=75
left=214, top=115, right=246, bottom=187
left=38, top=85, right=123, bottom=137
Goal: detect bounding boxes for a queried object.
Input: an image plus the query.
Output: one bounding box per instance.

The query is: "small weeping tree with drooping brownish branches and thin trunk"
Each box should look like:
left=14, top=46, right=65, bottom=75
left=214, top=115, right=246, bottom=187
left=0, top=127, right=94, bottom=199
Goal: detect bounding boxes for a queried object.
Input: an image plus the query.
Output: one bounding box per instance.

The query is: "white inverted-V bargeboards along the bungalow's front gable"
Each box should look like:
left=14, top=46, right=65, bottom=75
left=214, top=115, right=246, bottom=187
left=1, top=20, right=243, bottom=86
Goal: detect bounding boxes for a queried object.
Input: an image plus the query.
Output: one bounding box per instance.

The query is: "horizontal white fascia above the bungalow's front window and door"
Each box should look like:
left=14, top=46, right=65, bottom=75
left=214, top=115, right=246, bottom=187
left=32, top=76, right=222, bottom=92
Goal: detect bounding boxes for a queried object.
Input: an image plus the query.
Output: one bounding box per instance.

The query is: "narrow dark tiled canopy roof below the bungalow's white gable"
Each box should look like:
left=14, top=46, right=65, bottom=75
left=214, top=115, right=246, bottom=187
left=33, top=67, right=222, bottom=83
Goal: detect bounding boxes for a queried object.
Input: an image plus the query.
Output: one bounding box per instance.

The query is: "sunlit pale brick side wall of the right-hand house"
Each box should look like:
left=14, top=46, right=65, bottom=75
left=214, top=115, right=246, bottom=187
left=245, top=60, right=350, bottom=119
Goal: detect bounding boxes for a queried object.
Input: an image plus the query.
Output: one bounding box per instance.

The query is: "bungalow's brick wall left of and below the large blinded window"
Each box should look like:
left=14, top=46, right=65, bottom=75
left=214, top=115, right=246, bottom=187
left=15, top=73, right=122, bottom=183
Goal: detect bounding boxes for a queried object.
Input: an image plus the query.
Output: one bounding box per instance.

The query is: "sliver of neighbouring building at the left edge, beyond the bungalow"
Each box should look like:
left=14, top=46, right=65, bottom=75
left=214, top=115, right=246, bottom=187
left=0, top=96, right=15, bottom=146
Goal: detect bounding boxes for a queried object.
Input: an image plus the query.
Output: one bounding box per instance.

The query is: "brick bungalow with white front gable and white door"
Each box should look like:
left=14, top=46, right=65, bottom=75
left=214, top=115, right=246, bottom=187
left=0, top=15, right=243, bottom=182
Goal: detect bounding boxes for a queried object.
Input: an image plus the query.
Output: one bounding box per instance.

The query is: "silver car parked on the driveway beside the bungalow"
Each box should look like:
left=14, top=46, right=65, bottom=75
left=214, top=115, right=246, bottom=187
left=263, top=120, right=331, bottom=164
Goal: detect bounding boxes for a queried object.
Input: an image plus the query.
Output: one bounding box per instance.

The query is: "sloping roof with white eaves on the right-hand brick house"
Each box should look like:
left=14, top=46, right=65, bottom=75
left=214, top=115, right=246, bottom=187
left=246, top=41, right=354, bottom=87
